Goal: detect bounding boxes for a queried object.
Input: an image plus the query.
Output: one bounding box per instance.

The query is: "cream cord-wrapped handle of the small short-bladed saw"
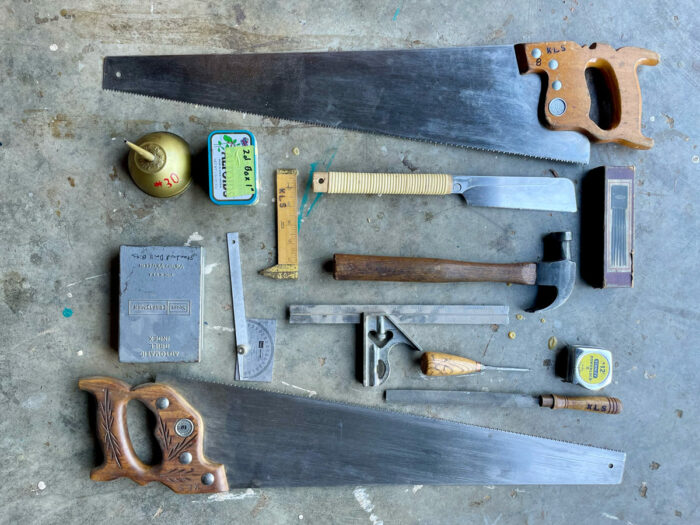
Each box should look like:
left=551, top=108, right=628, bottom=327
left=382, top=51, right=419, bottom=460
left=313, top=171, right=452, bottom=195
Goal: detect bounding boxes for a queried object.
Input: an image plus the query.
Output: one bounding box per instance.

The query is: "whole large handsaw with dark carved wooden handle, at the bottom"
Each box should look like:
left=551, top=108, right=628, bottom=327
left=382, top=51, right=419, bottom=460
left=79, top=377, right=625, bottom=493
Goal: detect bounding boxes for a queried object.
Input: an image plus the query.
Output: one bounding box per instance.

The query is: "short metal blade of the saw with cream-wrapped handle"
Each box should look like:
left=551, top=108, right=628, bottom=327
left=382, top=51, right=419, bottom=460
left=452, top=176, right=576, bottom=212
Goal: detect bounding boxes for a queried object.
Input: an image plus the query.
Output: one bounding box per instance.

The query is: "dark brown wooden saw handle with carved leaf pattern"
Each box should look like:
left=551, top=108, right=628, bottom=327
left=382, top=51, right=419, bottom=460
left=78, top=377, right=228, bottom=494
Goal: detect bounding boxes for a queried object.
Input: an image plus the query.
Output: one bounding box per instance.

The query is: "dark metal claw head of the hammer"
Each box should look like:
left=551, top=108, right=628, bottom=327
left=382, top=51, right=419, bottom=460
left=528, top=232, right=576, bottom=312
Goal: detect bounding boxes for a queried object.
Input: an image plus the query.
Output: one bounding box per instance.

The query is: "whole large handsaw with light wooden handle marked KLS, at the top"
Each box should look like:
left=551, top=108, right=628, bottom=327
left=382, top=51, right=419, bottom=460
left=102, top=41, right=659, bottom=163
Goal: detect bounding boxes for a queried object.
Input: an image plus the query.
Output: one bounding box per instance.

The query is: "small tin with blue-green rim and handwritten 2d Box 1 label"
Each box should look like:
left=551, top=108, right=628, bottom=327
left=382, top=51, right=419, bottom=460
left=212, top=130, right=258, bottom=206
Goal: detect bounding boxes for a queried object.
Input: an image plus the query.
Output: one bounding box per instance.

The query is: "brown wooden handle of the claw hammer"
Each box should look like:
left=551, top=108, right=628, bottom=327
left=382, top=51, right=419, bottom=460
left=333, top=253, right=537, bottom=284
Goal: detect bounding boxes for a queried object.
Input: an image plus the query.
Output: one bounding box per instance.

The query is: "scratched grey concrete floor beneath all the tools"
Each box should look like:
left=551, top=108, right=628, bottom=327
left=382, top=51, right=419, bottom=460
left=0, top=0, right=700, bottom=525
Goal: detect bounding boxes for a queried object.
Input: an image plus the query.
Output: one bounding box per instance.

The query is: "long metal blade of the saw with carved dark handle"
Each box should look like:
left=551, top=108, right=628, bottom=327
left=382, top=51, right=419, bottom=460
left=157, top=376, right=625, bottom=488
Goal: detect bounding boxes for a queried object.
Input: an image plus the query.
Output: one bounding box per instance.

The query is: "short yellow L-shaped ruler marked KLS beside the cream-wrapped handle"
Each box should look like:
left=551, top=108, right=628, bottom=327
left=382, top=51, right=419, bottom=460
left=260, top=170, right=299, bottom=279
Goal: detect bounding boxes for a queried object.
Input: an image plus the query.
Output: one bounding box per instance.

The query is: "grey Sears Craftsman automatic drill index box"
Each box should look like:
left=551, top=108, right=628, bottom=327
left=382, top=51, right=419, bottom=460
left=119, top=246, right=204, bottom=363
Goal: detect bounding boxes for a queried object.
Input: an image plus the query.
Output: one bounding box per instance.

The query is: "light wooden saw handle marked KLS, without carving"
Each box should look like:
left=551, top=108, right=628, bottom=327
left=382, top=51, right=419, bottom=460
left=515, top=41, right=659, bottom=149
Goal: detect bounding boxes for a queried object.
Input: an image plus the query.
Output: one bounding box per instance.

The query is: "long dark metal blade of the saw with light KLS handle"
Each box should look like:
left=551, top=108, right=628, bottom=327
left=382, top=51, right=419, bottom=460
left=102, top=46, right=590, bottom=163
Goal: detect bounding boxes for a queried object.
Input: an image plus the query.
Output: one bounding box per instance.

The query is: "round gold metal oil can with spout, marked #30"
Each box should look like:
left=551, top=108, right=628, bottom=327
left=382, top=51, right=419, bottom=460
left=124, top=131, right=192, bottom=198
